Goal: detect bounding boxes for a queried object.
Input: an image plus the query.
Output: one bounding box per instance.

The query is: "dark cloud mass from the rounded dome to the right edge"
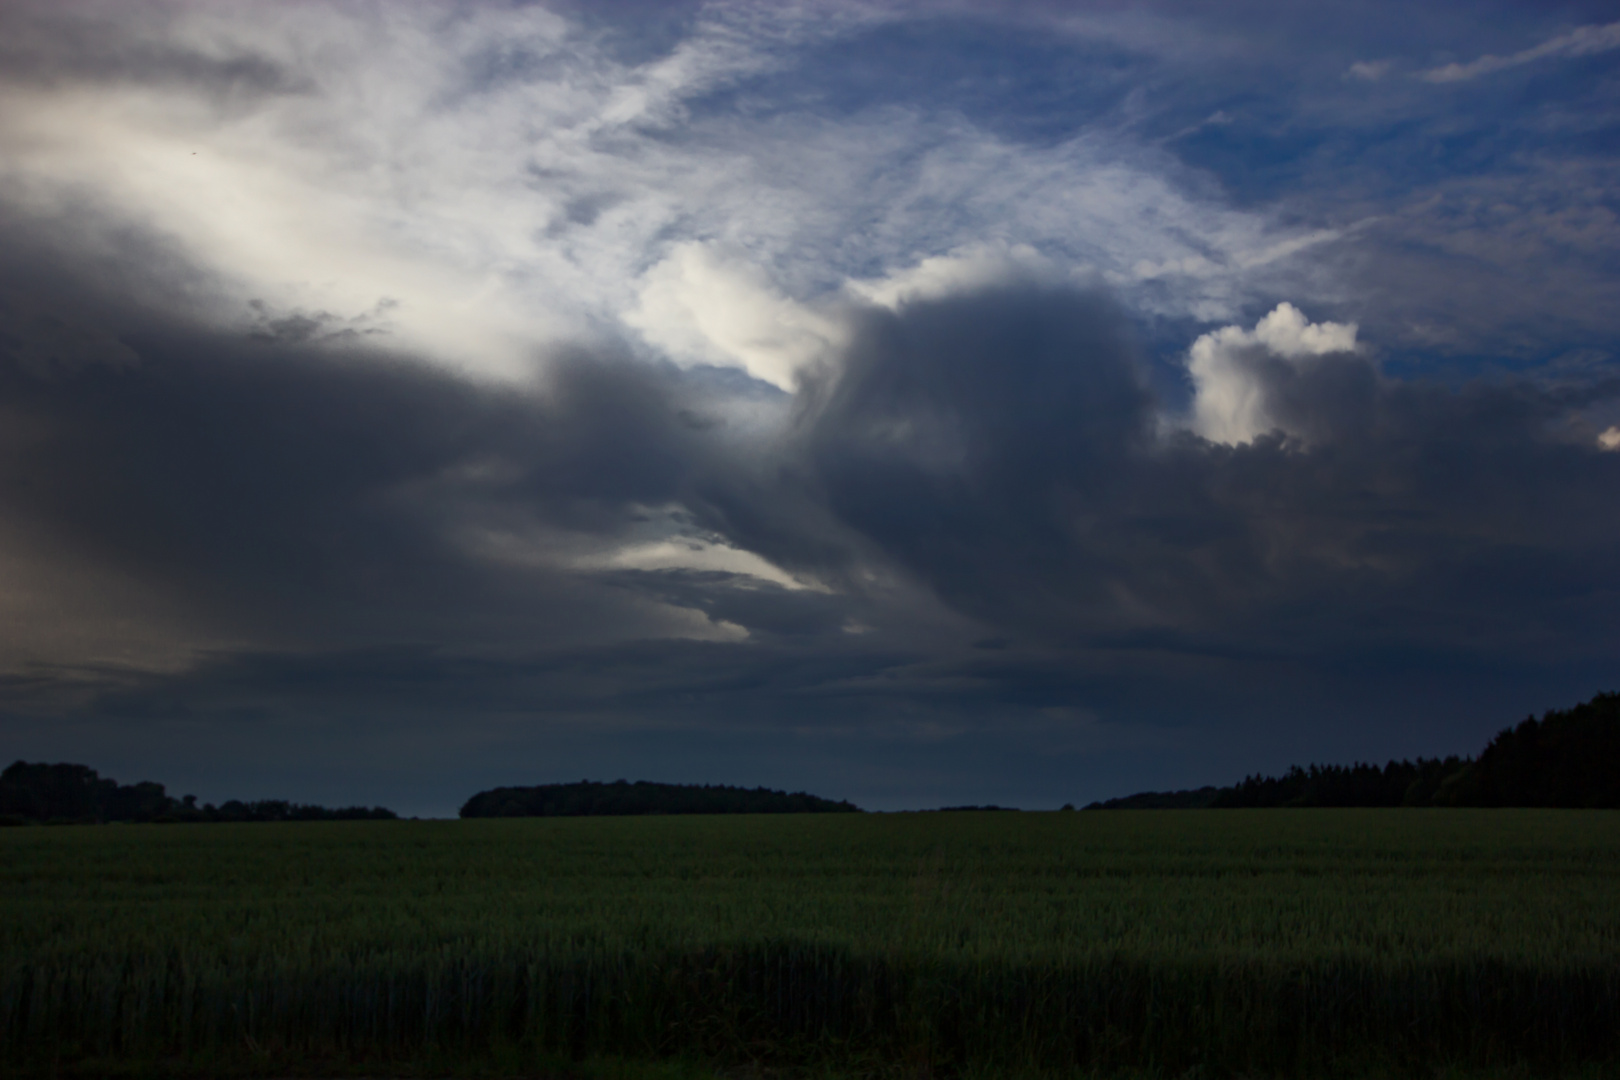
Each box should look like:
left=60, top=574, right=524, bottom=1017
left=777, top=290, right=1620, bottom=667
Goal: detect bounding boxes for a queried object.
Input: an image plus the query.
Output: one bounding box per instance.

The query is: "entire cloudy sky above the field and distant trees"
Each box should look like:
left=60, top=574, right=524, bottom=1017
left=0, top=0, right=1620, bottom=816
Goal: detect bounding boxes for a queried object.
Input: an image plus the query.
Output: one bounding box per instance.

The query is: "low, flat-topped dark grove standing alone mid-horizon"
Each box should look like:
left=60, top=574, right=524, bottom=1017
left=462, top=780, right=860, bottom=818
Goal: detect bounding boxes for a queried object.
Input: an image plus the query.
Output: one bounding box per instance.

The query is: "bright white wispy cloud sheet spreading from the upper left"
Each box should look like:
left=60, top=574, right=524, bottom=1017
left=0, top=3, right=1347, bottom=387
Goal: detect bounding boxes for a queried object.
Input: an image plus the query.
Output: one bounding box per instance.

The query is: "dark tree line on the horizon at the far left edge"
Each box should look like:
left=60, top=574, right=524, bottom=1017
left=0, top=761, right=399, bottom=824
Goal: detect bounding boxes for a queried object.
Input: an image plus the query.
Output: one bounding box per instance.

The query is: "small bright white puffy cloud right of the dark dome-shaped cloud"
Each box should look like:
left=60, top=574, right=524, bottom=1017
left=1187, top=303, right=1356, bottom=445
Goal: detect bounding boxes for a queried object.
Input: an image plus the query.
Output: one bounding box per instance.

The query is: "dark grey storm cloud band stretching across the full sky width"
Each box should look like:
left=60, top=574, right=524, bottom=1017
left=0, top=238, right=1620, bottom=751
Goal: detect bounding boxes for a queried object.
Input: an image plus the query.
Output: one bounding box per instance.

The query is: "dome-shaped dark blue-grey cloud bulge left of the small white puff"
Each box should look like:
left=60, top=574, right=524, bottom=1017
left=790, top=290, right=1152, bottom=637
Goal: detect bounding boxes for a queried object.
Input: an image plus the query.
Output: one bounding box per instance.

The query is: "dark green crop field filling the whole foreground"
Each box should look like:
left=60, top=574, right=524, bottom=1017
left=0, top=810, right=1620, bottom=1077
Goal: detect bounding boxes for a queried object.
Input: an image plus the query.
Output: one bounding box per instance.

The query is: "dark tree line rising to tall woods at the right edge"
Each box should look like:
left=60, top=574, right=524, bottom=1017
left=1087, top=693, right=1620, bottom=810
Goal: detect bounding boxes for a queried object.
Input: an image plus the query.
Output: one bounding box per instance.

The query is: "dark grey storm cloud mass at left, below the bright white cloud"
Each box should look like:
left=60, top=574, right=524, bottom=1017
left=0, top=239, right=729, bottom=660
